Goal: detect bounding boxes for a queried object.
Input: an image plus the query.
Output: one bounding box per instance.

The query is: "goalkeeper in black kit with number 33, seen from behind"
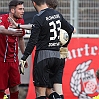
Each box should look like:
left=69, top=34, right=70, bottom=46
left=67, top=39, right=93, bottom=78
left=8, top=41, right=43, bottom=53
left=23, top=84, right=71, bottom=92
left=10, top=0, right=75, bottom=99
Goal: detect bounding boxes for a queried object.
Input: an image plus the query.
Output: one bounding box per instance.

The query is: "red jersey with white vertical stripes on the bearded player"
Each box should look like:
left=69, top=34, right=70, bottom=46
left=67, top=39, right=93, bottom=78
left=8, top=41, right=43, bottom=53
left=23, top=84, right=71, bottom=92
left=0, top=14, right=25, bottom=62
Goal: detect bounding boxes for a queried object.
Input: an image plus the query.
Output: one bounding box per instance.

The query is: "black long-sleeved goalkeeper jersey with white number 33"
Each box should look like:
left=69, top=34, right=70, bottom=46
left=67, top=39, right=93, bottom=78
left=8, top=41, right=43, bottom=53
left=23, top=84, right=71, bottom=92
left=24, top=8, right=74, bottom=58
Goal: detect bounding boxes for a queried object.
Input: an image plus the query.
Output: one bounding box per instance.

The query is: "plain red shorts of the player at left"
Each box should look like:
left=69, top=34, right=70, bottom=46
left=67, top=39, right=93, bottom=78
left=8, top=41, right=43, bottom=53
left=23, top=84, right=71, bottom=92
left=0, top=61, right=20, bottom=90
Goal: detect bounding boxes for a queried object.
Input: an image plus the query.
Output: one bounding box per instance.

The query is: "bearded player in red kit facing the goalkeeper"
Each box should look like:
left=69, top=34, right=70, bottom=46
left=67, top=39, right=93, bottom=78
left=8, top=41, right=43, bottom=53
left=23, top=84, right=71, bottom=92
left=0, top=0, right=27, bottom=99
